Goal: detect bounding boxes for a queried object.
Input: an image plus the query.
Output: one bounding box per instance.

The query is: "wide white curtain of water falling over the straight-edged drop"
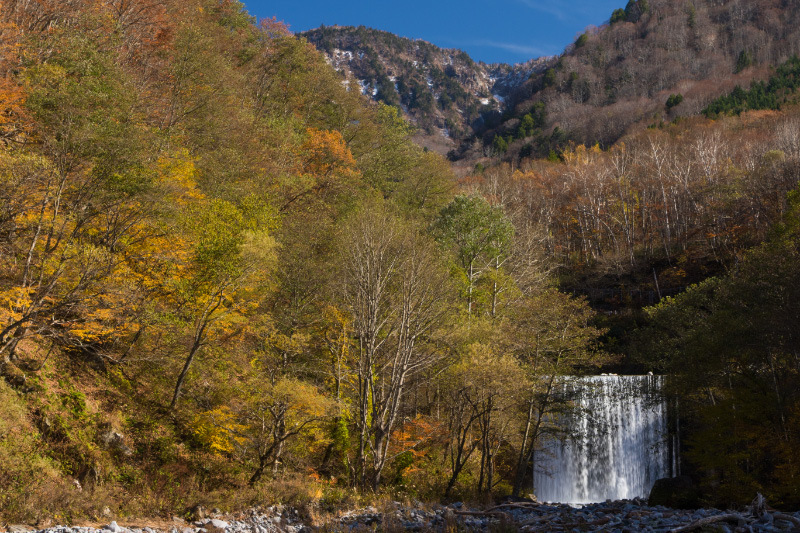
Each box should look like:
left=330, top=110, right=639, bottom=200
left=534, top=376, right=675, bottom=504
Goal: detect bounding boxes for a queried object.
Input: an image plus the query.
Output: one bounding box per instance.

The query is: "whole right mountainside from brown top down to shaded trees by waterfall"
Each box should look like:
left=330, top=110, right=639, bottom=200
left=294, top=0, right=800, bottom=505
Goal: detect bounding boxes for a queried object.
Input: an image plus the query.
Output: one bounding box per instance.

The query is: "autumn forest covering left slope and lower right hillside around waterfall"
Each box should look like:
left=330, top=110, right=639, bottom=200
left=0, top=0, right=800, bottom=520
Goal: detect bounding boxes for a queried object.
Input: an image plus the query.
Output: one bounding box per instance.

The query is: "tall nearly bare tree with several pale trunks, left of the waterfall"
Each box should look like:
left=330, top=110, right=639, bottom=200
left=342, top=206, right=448, bottom=489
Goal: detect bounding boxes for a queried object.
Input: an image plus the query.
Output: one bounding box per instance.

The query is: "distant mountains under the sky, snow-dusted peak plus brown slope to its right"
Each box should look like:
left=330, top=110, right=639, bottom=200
left=299, top=0, right=800, bottom=167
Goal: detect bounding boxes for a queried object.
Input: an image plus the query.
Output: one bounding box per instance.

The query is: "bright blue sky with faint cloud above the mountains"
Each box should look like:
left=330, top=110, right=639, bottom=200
left=243, top=0, right=626, bottom=63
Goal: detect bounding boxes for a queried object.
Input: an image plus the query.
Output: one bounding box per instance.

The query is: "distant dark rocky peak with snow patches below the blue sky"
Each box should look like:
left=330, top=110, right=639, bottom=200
left=300, top=26, right=550, bottom=153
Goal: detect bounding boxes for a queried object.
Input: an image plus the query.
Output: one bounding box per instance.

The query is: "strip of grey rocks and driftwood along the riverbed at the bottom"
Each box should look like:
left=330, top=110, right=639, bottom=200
left=6, top=499, right=800, bottom=533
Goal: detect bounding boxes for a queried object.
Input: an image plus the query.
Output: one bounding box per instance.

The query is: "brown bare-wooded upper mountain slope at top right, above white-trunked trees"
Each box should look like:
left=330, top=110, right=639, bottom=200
left=459, top=0, right=800, bottom=160
